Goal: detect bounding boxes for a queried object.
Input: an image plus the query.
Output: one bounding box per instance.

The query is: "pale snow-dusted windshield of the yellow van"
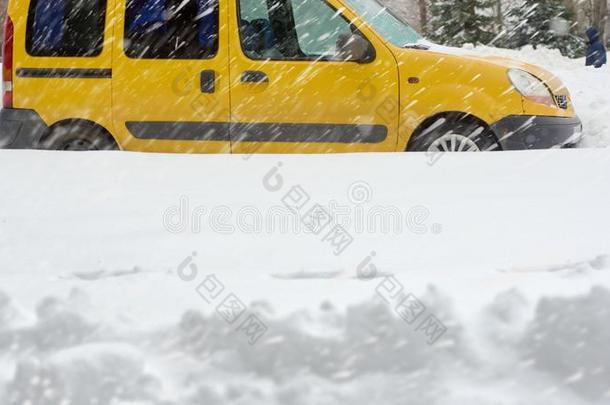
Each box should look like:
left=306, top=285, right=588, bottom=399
left=346, top=0, right=422, bottom=47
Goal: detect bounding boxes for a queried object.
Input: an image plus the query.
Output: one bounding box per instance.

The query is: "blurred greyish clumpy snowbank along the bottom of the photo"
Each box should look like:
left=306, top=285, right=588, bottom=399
left=0, top=284, right=610, bottom=405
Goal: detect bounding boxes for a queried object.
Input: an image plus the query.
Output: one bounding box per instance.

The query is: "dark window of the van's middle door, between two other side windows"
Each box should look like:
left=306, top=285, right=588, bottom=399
left=125, top=0, right=218, bottom=59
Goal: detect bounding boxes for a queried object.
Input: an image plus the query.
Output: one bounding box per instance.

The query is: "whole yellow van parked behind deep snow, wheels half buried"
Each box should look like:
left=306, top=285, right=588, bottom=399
left=0, top=0, right=582, bottom=153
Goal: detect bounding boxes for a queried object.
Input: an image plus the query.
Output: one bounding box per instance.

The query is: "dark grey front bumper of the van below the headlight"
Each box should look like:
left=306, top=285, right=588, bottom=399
left=491, top=115, right=582, bottom=150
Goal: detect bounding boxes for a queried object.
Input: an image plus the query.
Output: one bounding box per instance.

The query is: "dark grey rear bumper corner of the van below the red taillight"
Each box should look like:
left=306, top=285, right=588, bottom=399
left=0, top=108, right=49, bottom=149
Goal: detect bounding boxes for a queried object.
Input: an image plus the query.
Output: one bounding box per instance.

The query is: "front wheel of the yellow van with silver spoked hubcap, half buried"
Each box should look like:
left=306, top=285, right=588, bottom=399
left=407, top=116, right=499, bottom=153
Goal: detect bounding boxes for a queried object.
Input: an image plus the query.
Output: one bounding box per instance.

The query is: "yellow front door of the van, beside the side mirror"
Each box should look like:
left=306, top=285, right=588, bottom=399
left=229, top=0, right=399, bottom=153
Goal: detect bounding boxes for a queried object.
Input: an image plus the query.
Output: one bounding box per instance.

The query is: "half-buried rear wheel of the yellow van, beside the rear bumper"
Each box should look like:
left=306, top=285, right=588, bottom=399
left=42, top=124, right=119, bottom=151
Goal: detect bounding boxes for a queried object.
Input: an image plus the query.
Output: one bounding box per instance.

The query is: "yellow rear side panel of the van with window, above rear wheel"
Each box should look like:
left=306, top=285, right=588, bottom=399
left=9, top=0, right=113, bottom=129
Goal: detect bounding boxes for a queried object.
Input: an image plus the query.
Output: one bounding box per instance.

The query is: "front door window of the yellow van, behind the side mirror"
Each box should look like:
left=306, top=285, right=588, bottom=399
left=238, top=0, right=374, bottom=61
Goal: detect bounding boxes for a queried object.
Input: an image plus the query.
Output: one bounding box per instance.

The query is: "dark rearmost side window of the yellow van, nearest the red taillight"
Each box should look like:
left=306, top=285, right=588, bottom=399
left=26, top=0, right=106, bottom=56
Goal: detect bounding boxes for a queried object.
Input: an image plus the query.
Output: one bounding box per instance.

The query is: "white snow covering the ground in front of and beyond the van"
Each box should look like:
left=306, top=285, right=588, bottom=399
left=0, top=45, right=610, bottom=405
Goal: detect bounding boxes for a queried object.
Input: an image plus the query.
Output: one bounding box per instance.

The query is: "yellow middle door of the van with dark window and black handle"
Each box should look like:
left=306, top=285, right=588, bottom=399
left=112, top=0, right=230, bottom=153
